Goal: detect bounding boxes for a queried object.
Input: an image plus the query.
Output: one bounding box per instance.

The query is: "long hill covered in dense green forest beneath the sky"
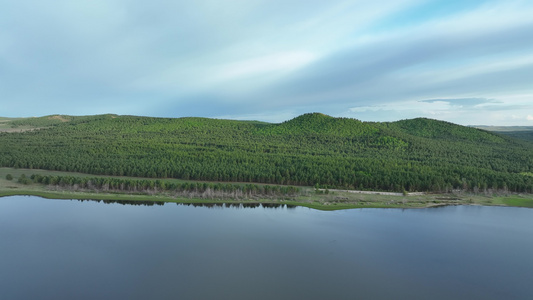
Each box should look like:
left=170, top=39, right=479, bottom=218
left=0, top=113, right=533, bottom=192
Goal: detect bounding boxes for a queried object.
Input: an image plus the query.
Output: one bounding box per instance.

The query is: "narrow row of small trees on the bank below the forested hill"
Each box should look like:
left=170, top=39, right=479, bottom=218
left=30, top=174, right=300, bottom=199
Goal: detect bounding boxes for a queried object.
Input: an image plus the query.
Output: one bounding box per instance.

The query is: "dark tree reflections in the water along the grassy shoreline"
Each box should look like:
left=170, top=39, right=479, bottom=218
left=73, top=199, right=296, bottom=209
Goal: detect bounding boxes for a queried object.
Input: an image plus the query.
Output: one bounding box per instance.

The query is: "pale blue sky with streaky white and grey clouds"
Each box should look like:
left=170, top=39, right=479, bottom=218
left=0, top=0, right=533, bottom=126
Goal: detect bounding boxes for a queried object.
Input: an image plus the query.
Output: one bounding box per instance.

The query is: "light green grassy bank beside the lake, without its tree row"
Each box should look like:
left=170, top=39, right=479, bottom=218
left=0, top=168, right=533, bottom=210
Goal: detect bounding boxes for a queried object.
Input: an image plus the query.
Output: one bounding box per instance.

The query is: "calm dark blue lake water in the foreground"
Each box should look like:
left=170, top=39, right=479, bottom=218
left=0, top=197, right=533, bottom=299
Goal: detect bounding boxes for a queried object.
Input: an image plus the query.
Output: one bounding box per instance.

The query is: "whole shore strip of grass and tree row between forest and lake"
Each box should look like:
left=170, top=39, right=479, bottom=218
left=4, top=168, right=533, bottom=210
